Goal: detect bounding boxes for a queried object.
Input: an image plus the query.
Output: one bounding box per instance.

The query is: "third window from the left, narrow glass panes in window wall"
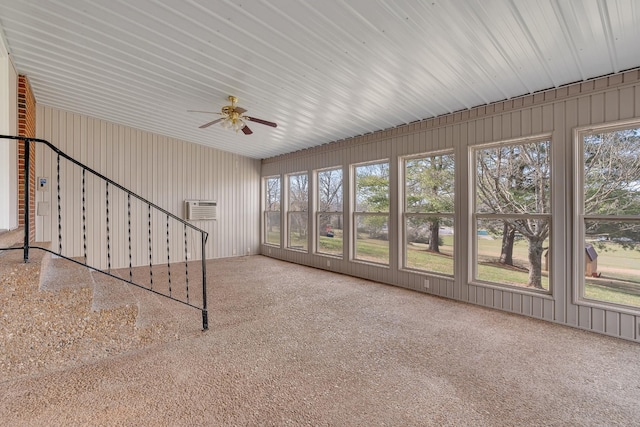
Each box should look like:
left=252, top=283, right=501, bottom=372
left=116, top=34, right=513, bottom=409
left=316, top=168, right=343, bottom=256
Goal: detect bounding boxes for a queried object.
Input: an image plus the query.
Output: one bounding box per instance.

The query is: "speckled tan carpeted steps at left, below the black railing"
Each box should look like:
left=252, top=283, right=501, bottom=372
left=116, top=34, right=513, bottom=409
left=0, top=244, right=201, bottom=382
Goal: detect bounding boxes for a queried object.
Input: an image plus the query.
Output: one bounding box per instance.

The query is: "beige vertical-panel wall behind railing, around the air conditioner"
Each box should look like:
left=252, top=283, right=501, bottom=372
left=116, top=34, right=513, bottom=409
left=37, top=106, right=260, bottom=268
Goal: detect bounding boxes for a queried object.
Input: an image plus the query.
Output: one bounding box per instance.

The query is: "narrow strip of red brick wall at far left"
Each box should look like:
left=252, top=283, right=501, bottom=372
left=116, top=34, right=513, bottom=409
left=18, top=75, right=36, bottom=241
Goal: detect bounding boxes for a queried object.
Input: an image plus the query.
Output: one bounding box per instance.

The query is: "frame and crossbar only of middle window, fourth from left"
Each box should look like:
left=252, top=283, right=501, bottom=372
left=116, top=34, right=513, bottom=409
left=349, top=158, right=392, bottom=268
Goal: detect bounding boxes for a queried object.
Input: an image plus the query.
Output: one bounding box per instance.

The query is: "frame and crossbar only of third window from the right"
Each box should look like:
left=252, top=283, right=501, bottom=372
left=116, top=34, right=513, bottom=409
left=398, top=148, right=457, bottom=280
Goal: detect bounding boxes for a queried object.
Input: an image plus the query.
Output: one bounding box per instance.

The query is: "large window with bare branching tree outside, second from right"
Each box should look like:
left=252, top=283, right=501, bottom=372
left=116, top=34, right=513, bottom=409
left=472, top=140, right=551, bottom=291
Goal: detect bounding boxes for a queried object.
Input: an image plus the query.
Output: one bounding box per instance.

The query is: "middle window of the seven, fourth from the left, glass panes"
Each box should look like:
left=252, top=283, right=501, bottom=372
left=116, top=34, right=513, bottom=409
left=353, top=163, right=389, bottom=264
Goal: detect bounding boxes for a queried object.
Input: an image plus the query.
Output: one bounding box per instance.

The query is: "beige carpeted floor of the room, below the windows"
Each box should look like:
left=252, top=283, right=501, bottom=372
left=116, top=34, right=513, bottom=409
left=0, top=256, right=640, bottom=426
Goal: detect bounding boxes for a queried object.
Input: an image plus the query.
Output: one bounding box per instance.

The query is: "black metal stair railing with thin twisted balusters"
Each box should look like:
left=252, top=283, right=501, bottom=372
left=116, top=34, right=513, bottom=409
left=0, top=135, right=209, bottom=330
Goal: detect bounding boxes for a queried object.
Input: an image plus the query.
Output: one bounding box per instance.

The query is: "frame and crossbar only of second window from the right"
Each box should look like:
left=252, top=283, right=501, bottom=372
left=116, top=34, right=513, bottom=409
left=468, top=133, right=555, bottom=298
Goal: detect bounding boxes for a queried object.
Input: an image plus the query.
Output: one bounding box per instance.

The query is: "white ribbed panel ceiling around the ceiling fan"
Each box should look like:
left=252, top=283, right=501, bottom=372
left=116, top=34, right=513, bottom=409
left=0, top=0, right=640, bottom=158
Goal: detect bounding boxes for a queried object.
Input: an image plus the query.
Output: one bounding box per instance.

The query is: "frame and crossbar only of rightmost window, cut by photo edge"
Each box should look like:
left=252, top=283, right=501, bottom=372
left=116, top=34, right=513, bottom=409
left=572, top=118, right=640, bottom=316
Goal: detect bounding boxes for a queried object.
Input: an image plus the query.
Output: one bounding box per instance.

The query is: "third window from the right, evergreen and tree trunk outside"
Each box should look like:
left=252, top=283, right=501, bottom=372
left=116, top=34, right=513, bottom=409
left=404, top=153, right=455, bottom=276
